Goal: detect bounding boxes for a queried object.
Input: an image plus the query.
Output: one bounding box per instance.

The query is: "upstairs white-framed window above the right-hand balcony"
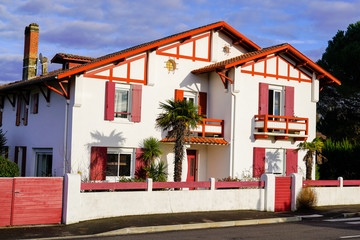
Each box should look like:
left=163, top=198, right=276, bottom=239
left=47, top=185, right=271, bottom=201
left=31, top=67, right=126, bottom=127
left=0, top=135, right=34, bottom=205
left=268, top=86, right=284, bottom=116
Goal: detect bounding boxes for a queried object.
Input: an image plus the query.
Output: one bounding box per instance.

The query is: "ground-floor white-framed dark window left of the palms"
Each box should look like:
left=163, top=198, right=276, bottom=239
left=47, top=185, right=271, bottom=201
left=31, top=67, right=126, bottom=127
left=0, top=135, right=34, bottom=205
left=106, top=148, right=134, bottom=177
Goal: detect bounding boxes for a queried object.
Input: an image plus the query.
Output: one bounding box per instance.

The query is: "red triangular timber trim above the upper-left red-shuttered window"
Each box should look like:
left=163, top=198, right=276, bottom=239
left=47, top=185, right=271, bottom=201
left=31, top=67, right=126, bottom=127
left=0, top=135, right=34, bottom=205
left=84, top=54, right=147, bottom=85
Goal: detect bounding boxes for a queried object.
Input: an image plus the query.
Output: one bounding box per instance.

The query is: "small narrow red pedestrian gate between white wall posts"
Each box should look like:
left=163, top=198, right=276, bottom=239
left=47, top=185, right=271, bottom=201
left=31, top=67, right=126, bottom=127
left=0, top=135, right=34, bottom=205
left=275, top=177, right=291, bottom=212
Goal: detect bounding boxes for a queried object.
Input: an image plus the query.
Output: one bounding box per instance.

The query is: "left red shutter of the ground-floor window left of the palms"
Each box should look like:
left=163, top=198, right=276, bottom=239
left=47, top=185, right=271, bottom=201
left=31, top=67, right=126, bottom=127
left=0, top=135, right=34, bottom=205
left=90, top=147, right=107, bottom=181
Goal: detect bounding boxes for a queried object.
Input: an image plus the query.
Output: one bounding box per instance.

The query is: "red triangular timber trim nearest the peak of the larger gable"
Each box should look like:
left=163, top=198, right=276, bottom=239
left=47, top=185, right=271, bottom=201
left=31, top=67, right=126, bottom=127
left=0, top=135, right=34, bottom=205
left=156, top=33, right=211, bottom=62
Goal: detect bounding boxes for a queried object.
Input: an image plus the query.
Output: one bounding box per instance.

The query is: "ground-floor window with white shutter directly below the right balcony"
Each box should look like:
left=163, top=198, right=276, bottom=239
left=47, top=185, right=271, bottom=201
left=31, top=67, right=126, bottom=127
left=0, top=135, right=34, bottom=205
left=265, top=149, right=286, bottom=175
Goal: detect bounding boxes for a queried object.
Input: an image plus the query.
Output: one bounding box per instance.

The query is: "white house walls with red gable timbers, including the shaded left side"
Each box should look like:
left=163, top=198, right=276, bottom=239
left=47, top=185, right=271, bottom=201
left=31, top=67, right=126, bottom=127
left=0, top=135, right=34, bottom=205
left=0, top=22, right=338, bottom=181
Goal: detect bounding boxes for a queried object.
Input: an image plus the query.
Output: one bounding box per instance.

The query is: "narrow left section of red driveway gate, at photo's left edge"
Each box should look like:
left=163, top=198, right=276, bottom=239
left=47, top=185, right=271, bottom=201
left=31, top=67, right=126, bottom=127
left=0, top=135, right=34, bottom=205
left=0, top=178, right=13, bottom=227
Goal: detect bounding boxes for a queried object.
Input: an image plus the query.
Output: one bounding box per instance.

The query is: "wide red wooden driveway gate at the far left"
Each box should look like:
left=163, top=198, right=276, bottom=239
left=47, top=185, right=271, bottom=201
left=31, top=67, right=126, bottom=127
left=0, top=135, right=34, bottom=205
left=0, top=178, right=63, bottom=226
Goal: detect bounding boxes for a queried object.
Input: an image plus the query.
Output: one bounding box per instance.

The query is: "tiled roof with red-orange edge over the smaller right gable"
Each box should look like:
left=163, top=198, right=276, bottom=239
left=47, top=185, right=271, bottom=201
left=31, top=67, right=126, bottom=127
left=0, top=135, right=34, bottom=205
left=191, top=43, right=341, bottom=85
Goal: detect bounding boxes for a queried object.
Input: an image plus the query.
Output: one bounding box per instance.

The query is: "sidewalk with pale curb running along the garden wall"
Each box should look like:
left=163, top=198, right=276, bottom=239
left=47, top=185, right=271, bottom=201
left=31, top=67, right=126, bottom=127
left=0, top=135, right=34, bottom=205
left=0, top=205, right=360, bottom=239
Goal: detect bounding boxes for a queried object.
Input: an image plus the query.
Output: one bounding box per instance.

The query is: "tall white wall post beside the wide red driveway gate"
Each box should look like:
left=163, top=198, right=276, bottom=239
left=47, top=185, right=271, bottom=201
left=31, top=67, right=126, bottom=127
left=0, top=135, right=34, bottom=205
left=63, top=173, right=81, bottom=224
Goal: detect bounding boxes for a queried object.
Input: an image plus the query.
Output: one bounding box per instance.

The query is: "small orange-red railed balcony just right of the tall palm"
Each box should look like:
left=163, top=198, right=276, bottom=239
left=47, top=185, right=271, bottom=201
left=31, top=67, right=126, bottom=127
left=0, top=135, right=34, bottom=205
left=191, top=118, right=224, bottom=138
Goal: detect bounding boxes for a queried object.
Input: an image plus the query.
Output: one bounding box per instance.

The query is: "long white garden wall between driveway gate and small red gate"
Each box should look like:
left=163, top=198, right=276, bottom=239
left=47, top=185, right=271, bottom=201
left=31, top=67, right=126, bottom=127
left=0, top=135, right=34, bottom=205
left=64, top=174, right=265, bottom=224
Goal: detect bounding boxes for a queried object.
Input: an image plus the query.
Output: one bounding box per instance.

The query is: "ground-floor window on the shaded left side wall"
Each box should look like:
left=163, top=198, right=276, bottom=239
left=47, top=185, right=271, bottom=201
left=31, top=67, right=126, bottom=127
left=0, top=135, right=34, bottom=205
left=35, top=149, right=52, bottom=177
